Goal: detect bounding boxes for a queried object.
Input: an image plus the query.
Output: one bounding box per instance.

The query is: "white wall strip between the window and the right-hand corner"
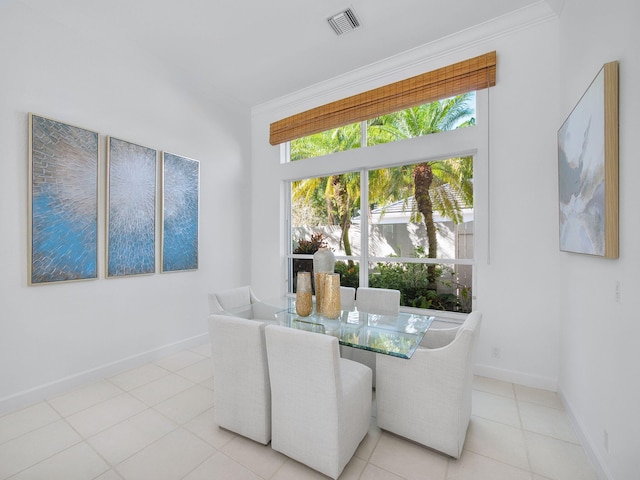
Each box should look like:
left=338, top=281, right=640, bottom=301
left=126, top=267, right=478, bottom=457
left=476, top=19, right=561, bottom=390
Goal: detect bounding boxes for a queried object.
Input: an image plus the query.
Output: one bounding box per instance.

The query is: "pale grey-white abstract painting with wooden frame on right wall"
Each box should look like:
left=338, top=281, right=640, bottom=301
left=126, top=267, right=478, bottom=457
left=558, top=62, right=618, bottom=258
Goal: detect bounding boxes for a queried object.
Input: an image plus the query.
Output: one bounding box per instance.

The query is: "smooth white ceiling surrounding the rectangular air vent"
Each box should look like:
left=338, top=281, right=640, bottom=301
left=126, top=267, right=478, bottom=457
left=16, top=0, right=562, bottom=107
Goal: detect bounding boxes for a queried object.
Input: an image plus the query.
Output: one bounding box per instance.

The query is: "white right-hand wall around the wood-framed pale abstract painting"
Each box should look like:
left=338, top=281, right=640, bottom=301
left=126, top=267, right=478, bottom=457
left=556, top=0, right=640, bottom=480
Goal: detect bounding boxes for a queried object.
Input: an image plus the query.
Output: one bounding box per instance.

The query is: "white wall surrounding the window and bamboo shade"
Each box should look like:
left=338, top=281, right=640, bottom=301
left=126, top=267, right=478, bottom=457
left=252, top=2, right=562, bottom=390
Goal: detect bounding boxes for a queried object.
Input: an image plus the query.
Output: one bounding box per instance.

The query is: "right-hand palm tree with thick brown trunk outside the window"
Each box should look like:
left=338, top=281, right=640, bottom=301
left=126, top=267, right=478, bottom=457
left=368, top=93, right=475, bottom=290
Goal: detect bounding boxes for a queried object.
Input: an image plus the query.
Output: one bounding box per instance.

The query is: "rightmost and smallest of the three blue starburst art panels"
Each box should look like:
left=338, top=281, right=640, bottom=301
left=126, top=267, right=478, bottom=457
left=161, top=152, right=200, bottom=272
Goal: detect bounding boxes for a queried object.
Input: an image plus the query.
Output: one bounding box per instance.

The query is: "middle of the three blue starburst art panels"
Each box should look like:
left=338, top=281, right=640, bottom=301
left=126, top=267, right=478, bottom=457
left=106, top=137, right=157, bottom=277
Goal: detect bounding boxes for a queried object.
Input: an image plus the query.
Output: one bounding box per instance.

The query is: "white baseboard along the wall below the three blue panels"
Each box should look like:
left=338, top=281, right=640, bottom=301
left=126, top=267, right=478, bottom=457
left=0, top=333, right=209, bottom=415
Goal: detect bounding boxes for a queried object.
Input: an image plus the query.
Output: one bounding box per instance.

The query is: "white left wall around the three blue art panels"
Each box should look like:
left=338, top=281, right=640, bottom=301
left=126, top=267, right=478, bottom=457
left=0, top=2, right=251, bottom=411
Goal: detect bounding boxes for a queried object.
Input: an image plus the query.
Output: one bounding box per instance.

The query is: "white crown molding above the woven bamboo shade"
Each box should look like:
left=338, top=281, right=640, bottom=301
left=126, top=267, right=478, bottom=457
left=251, top=0, right=558, bottom=117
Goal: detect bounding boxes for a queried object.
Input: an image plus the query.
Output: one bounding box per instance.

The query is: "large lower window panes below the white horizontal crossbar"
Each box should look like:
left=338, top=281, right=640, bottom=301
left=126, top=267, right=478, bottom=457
left=289, top=157, right=473, bottom=312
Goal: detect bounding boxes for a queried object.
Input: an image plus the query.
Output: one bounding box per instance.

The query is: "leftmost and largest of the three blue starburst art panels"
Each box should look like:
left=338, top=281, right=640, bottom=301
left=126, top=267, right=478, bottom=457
left=28, top=114, right=99, bottom=285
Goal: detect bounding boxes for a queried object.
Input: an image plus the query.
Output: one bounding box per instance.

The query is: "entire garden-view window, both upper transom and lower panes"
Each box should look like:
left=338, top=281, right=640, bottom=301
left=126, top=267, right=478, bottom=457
left=287, top=97, right=475, bottom=312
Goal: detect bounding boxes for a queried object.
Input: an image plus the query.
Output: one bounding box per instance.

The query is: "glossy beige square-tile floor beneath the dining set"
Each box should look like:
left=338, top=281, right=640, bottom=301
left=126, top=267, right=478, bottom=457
left=0, top=345, right=597, bottom=480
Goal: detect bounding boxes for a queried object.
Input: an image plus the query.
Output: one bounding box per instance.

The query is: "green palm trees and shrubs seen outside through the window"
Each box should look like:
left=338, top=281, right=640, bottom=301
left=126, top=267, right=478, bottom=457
left=290, top=94, right=475, bottom=312
